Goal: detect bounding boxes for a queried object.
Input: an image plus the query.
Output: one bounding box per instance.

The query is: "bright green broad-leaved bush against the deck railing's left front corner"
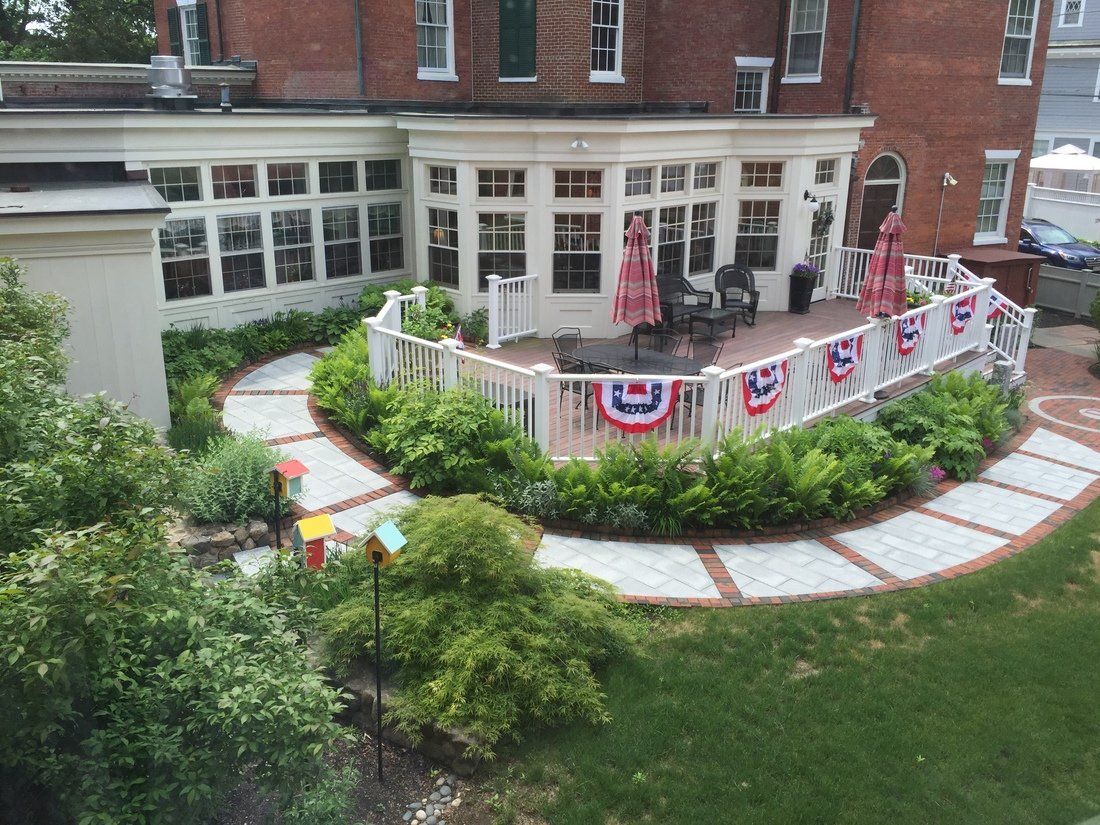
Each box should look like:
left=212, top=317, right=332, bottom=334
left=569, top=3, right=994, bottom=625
left=366, top=385, right=525, bottom=492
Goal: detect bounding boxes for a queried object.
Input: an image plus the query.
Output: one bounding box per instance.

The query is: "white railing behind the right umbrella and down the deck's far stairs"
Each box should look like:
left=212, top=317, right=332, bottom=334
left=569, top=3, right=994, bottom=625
left=833, top=246, right=1035, bottom=374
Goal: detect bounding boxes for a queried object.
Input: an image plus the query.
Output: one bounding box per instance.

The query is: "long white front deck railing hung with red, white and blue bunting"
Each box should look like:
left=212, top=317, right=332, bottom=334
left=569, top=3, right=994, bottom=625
left=366, top=275, right=998, bottom=461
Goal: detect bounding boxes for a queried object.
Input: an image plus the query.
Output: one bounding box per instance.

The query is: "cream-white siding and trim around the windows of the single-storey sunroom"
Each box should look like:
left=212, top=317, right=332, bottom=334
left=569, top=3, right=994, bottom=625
left=0, top=110, right=873, bottom=343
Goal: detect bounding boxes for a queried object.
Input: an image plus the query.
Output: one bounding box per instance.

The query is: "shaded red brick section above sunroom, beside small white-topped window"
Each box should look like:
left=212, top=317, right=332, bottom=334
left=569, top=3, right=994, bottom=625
left=645, top=0, right=783, bottom=112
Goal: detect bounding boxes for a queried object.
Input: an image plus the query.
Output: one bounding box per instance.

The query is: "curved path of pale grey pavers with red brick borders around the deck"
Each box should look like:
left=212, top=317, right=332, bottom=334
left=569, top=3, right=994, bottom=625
left=216, top=350, right=1100, bottom=607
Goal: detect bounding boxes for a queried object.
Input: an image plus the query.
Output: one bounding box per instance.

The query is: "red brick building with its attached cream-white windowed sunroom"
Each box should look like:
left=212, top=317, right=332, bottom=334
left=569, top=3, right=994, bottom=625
left=0, top=0, right=1052, bottom=345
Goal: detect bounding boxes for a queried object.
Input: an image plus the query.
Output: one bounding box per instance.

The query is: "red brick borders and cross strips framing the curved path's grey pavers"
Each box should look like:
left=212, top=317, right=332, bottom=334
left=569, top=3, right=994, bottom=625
left=213, top=347, right=1100, bottom=607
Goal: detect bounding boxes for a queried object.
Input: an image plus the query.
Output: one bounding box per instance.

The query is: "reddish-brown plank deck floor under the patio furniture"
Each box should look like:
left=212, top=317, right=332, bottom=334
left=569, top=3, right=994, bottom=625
left=471, top=298, right=867, bottom=369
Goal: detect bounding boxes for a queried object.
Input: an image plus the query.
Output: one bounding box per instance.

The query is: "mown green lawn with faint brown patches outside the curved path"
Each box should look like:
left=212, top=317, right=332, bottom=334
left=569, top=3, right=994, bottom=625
left=494, top=502, right=1100, bottom=825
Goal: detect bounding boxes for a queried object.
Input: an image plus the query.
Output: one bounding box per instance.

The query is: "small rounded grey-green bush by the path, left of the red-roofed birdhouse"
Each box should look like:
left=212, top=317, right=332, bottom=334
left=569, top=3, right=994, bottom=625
left=179, top=436, right=284, bottom=524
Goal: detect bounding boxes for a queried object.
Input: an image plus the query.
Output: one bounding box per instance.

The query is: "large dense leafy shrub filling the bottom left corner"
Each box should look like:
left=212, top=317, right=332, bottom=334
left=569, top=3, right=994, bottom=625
left=0, top=525, right=341, bottom=825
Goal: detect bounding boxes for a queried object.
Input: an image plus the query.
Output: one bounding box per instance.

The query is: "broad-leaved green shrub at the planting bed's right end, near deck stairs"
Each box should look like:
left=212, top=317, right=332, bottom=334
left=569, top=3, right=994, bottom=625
left=878, top=373, right=1022, bottom=481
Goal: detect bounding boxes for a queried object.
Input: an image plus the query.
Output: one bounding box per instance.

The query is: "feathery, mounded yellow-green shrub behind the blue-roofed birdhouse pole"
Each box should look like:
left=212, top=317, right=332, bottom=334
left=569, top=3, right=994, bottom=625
left=321, top=495, right=634, bottom=758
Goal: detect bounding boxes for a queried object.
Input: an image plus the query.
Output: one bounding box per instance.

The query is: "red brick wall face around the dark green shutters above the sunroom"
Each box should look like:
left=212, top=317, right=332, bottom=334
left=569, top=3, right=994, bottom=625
left=472, top=0, right=653, bottom=103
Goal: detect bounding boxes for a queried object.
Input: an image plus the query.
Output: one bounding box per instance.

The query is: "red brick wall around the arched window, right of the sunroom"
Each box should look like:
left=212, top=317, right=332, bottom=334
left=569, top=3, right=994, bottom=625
left=829, top=0, right=1052, bottom=254
